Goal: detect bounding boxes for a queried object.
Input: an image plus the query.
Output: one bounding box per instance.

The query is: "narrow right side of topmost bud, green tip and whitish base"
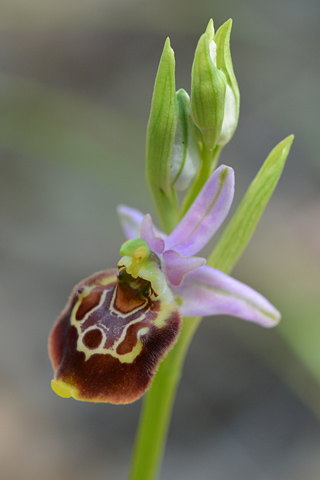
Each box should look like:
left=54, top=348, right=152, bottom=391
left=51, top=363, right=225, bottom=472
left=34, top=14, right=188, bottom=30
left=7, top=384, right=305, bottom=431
left=214, top=19, right=240, bottom=145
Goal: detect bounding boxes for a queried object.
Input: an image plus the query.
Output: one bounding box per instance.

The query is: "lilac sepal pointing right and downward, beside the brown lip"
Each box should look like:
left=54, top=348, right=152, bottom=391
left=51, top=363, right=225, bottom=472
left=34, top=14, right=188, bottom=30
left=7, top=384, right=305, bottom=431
left=173, top=265, right=280, bottom=327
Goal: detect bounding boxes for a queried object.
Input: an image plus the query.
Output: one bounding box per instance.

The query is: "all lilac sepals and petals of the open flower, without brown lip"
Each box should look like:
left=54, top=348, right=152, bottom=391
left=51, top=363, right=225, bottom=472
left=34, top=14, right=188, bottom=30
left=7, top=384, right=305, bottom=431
left=118, top=165, right=280, bottom=327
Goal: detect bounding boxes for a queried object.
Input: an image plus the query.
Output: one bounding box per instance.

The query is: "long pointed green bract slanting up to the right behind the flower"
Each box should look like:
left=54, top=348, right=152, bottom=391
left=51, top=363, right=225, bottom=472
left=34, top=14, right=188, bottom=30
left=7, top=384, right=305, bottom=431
left=207, top=135, right=294, bottom=273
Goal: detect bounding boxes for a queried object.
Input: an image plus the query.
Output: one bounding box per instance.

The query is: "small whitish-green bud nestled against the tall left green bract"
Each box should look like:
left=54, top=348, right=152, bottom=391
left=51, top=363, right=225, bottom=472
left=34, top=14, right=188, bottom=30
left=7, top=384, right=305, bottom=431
left=170, top=89, right=201, bottom=190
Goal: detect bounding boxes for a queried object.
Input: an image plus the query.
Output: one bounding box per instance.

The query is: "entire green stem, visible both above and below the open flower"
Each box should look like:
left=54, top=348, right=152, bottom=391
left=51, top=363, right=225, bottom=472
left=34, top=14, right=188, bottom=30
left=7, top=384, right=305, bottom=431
left=129, top=142, right=222, bottom=480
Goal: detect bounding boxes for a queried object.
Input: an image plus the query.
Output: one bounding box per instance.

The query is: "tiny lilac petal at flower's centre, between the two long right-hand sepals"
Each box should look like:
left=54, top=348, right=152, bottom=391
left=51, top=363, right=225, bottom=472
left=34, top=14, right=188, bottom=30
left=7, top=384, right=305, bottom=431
left=163, top=250, right=206, bottom=285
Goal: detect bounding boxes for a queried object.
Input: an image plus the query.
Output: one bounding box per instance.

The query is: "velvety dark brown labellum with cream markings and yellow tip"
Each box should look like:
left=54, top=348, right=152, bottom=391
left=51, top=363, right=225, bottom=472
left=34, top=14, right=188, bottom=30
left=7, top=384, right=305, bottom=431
left=49, top=269, right=181, bottom=404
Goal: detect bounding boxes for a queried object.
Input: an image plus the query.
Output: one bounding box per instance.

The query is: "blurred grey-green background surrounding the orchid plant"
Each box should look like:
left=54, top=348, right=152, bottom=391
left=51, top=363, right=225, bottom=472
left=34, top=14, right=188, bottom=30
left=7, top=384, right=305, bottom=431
left=0, top=0, right=320, bottom=480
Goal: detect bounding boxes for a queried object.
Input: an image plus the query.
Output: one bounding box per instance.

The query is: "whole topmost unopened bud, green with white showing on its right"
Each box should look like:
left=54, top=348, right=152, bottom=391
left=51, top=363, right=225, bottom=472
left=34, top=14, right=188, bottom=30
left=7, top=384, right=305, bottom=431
left=191, top=20, right=239, bottom=150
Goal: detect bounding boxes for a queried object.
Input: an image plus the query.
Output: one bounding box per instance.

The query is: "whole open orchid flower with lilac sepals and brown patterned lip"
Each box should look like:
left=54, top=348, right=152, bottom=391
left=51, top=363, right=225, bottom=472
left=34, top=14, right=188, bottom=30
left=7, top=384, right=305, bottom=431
left=49, top=165, right=280, bottom=403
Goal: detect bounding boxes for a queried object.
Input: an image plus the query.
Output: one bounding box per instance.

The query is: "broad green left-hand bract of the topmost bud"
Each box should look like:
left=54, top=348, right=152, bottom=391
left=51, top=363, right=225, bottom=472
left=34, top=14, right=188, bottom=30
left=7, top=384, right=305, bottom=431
left=191, top=20, right=227, bottom=150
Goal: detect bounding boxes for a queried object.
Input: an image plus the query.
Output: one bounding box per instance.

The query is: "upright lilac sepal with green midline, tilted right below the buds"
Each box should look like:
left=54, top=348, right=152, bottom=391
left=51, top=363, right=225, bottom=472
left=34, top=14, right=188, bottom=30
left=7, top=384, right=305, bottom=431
left=166, top=165, right=234, bottom=255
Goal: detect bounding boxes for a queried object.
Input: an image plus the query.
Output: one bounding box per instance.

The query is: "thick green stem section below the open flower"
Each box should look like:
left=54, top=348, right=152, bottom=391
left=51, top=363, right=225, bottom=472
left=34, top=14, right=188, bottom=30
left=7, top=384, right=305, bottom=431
left=129, top=318, right=201, bottom=480
